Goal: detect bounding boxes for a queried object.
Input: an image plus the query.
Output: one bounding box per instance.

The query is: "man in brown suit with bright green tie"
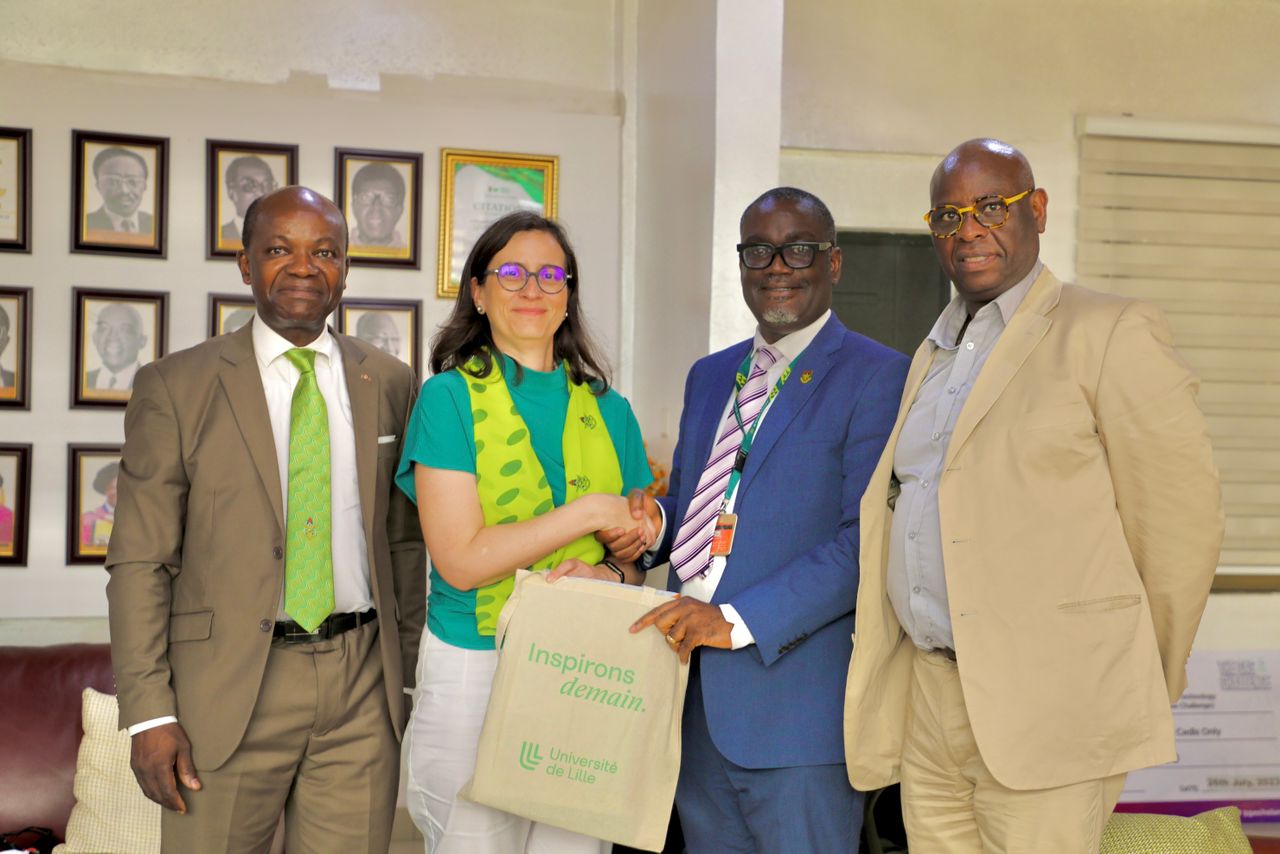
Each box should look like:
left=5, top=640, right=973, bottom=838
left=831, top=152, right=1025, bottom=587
left=106, top=187, right=425, bottom=853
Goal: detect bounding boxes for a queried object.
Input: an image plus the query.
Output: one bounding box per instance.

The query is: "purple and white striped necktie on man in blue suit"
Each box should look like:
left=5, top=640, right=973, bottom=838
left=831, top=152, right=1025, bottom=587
left=671, top=344, right=780, bottom=581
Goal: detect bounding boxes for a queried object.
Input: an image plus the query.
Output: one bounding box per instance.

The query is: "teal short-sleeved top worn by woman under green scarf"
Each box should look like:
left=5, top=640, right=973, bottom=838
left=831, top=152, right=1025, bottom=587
left=396, top=356, right=653, bottom=649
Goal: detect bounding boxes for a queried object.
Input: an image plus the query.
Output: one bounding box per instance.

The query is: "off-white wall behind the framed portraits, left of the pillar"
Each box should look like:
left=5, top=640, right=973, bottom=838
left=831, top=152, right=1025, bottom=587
left=0, top=0, right=621, bottom=624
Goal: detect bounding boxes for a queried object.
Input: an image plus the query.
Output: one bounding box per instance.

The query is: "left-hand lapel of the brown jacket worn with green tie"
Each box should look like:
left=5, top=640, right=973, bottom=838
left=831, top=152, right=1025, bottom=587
left=218, top=321, right=284, bottom=531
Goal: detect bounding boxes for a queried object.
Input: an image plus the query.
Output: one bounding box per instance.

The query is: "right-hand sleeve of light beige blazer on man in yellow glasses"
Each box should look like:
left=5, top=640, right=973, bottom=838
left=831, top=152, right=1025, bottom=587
left=1096, top=302, right=1224, bottom=702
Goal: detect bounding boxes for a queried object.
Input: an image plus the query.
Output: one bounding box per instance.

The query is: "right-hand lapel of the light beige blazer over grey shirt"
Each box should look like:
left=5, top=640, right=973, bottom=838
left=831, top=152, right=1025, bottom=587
left=943, top=268, right=1062, bottom=467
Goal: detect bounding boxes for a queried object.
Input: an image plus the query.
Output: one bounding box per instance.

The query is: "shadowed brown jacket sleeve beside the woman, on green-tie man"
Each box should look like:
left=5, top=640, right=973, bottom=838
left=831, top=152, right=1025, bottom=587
left=387, top=369, right=426, bottom=688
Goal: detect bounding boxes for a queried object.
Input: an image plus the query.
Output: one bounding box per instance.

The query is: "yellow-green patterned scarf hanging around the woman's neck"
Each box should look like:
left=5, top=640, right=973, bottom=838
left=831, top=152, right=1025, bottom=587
left=458, top=353, right=622, bottom=636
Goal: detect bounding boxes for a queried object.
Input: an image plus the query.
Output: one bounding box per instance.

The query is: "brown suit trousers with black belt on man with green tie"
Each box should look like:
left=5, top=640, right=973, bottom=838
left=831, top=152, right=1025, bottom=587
left=161, top=622, right=399, bottom=854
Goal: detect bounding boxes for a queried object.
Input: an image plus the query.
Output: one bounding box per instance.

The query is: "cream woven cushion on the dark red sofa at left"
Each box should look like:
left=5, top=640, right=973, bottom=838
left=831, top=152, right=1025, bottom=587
left=54, top=688, right=160, bottom=854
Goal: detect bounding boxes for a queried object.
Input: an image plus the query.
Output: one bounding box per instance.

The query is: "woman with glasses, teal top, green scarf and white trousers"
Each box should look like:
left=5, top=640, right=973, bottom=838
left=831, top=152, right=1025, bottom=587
left=396, top=211, right=654, bottom=854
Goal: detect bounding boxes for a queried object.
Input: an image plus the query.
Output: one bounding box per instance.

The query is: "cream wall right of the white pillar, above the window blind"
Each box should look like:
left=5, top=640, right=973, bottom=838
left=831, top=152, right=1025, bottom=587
left=782, top=0, right=1280, bottom=279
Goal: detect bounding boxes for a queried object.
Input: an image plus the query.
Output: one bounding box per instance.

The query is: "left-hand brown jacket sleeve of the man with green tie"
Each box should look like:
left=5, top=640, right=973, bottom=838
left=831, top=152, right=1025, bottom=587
left=106, top=365, right=188, bottom=729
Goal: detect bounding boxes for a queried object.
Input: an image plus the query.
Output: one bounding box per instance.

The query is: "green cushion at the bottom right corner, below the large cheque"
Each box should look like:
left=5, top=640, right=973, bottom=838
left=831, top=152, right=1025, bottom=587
left=1101, top=807, right=1253, bottom=854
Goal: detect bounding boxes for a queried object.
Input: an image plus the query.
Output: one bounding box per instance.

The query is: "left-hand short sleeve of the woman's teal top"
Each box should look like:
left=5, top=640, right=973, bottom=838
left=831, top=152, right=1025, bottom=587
left=396, top=371, right=476, bottom=504
